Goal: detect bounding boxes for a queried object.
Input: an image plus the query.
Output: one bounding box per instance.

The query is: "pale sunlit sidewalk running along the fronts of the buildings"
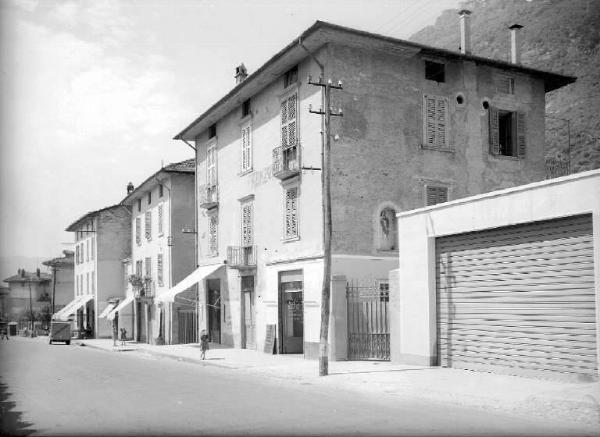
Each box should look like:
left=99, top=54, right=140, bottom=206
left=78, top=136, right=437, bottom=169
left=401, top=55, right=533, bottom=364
left=75, top=339, right=600, bottom=435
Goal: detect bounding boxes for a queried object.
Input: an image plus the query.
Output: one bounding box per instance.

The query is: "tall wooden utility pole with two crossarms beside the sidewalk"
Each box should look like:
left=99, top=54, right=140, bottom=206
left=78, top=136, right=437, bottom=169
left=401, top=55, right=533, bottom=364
left=308, top=76, right=343, bottom=376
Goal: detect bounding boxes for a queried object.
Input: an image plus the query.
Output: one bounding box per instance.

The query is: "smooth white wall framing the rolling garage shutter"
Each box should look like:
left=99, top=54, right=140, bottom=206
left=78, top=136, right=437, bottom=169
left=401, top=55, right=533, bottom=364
left=390, top=170, right=600, bottom=365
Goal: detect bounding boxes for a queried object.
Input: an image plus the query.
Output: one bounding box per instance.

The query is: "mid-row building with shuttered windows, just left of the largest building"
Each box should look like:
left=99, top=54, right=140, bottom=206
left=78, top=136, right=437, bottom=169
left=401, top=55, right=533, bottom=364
left=122, top=159, right=198, bottom=344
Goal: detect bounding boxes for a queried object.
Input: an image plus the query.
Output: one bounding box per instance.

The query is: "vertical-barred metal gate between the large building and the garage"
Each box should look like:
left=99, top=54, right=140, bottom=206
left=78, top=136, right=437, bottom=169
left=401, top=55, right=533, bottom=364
left=346, top=279, right=390, bottom=360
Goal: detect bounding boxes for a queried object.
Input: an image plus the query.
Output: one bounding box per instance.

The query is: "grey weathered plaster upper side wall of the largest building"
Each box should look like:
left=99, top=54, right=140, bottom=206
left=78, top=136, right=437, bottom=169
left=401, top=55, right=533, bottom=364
left=330, top=46, right=545, bottom=254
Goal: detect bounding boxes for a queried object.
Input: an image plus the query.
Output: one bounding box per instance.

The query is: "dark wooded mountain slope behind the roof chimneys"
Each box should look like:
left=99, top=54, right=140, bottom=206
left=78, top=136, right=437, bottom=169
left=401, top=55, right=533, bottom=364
left=410, top=0, right=600, bottom=172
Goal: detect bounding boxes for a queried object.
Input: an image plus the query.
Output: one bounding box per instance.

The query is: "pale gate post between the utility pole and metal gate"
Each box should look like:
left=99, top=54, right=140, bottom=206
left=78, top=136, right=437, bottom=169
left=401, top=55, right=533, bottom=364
left=329, top=275, right=348, bottom=361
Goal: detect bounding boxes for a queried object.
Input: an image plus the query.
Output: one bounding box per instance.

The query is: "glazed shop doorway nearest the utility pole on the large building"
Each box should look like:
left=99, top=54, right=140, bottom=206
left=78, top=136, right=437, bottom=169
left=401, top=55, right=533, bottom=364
left=279, top=270, right=304, bottom=354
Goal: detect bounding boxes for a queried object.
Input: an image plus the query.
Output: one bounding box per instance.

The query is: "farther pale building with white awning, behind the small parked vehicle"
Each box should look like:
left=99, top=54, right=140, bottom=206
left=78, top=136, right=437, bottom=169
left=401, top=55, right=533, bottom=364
left=54, top=204, right=131, bottom=337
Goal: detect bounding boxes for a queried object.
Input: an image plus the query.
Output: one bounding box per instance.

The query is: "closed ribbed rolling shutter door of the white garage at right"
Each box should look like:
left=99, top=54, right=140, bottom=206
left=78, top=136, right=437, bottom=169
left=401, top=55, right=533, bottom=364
left=436, top=215, right=598, bottom=379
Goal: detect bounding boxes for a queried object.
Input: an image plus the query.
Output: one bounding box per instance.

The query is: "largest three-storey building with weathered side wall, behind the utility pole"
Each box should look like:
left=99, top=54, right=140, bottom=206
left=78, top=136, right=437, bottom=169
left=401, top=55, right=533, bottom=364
left=175, top=19, right=574, bottom=359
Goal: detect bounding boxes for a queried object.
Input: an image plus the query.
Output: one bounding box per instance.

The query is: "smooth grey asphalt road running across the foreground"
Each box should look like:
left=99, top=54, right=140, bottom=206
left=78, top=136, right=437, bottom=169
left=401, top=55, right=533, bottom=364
left=0, top=338, right=592, bottom=436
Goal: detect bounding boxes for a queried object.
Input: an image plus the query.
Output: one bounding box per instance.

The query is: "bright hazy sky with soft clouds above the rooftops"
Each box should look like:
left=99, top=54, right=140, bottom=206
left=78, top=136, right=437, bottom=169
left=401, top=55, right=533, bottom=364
left=0, top=0, right=458, bottom=266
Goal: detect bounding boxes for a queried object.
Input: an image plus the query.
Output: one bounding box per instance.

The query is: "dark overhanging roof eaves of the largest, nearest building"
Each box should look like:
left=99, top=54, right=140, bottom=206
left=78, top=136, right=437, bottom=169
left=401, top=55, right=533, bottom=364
left=173, top=21, right=576, bottom=141
